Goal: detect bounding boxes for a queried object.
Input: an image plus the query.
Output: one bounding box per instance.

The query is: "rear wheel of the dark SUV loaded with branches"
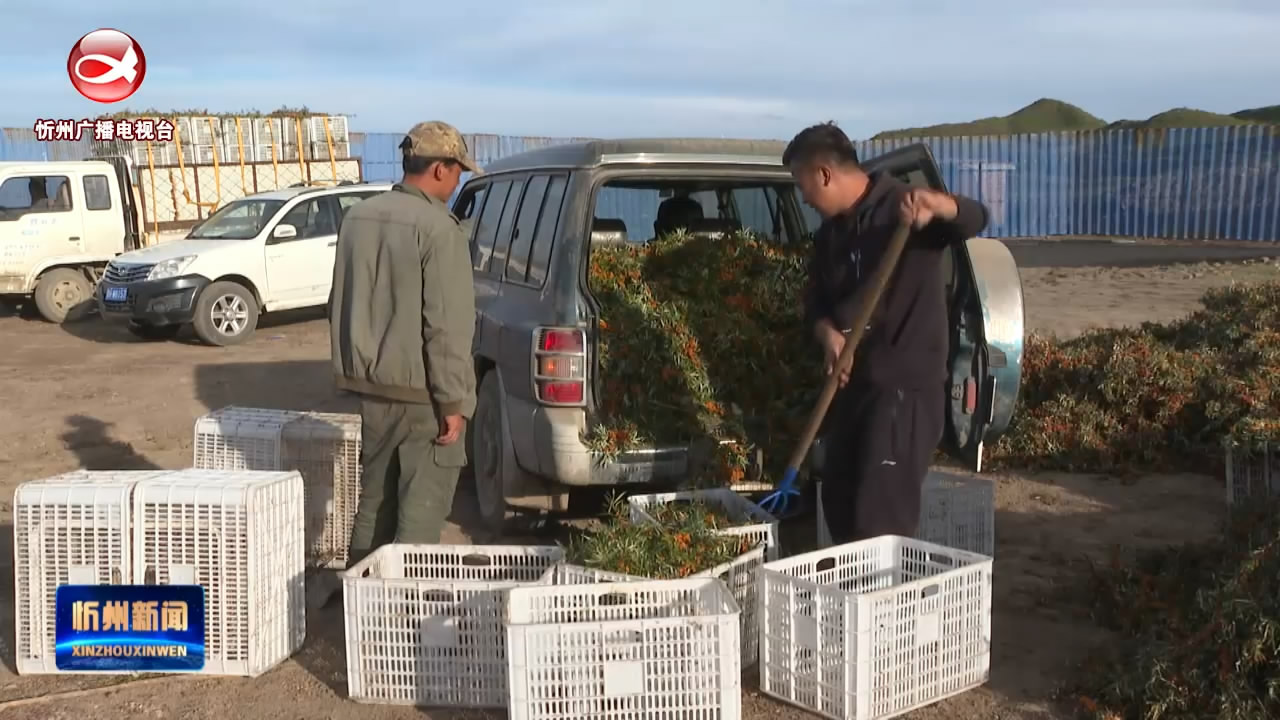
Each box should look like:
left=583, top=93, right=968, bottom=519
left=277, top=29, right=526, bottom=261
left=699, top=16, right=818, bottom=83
left=467, top=370, right=515, bottom=536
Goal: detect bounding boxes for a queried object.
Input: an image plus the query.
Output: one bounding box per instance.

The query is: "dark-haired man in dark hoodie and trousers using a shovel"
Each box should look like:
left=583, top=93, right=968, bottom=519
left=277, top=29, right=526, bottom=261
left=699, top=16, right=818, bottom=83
left=782, top=123, right=987, bottom=543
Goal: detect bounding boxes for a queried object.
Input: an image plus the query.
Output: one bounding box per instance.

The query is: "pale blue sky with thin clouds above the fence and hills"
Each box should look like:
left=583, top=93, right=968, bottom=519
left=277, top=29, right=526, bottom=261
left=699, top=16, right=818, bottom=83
left=0, top=0, right=1280, bottom=138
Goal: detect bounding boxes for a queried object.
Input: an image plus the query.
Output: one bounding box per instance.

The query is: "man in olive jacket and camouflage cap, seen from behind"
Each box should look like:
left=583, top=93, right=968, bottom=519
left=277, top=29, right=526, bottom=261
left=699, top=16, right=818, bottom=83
left=329, top=122, right=479, bottom=566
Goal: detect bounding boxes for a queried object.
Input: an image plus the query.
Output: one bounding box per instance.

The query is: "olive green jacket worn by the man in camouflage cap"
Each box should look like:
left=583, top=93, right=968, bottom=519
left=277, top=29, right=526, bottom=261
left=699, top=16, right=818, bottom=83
left=329, top=184, right=476, bottom=418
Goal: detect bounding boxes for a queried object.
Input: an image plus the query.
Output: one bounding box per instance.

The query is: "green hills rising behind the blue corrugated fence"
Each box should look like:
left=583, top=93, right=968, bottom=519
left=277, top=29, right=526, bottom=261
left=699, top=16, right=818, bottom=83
left=872, top=97, right=1280, bottom=140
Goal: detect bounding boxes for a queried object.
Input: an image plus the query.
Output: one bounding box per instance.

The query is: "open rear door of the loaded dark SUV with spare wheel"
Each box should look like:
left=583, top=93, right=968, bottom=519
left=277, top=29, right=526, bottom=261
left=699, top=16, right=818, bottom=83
left=863, top=145, right=1023, bottom=470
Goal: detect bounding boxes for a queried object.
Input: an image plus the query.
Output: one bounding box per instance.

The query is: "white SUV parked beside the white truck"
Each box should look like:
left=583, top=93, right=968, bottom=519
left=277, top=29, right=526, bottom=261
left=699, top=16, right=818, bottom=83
left=95, top=183, right=392, bottom=346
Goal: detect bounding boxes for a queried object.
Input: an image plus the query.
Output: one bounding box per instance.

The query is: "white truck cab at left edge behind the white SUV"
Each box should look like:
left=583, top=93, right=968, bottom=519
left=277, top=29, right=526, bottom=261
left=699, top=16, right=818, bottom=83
left=0, top=158, right=186, bottom=323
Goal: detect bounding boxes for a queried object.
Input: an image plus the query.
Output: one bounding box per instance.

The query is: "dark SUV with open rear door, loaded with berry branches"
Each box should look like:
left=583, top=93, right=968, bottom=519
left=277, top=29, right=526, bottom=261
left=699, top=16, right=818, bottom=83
left=453, top=140, right=1023, bottom=529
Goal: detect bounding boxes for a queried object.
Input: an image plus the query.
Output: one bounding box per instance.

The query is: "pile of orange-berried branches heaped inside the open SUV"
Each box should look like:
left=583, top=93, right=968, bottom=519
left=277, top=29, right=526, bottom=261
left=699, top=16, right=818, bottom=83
left=586, top=233, right=822, bottom=484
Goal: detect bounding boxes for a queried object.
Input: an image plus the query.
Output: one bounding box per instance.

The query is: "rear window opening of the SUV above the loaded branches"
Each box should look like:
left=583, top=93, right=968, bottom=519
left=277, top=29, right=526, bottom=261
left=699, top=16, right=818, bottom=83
left=593, top=178, right=818, bottom=245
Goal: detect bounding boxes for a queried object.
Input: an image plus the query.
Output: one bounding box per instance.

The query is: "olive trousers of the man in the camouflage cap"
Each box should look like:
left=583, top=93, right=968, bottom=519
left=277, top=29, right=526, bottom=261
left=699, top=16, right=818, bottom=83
left=347, top=397, right=467, bottom=568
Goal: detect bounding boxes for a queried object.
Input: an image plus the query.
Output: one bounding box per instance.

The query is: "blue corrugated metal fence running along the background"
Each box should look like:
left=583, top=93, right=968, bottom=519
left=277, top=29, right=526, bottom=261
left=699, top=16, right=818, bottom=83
left=0, top=126, right=1280, bottom=242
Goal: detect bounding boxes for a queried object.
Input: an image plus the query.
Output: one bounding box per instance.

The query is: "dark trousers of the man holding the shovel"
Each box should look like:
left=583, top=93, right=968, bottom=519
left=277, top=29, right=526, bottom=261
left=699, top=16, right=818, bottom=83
left=822, top=383, right=945, bottom=544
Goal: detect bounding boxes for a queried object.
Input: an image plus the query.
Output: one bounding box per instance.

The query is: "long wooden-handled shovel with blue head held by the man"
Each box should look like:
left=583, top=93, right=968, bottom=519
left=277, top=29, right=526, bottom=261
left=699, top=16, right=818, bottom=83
left=760, top=223, right=911, bottom=518
